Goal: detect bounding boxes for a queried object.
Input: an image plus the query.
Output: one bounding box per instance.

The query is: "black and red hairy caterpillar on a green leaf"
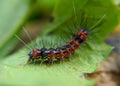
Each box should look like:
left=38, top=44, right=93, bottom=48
left=28, top=29, right=89, bottom=64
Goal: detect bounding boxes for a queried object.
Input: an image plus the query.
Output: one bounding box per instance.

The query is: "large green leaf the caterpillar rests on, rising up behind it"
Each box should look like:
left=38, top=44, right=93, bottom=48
left=0, top=0, right=117, bottom=86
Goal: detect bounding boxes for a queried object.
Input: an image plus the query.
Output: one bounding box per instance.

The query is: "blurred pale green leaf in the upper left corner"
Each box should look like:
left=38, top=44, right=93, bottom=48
left=0, top=0, right=31, bottom=57
